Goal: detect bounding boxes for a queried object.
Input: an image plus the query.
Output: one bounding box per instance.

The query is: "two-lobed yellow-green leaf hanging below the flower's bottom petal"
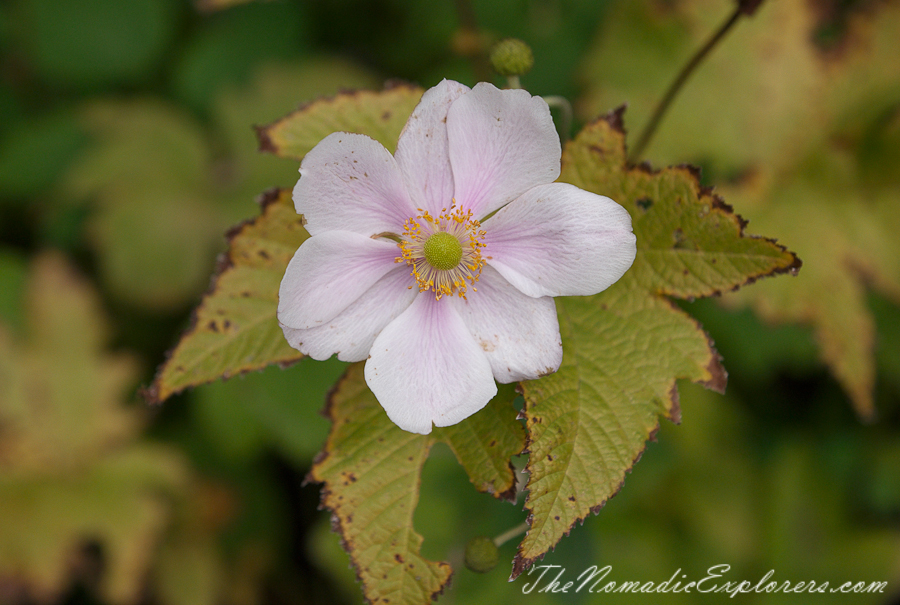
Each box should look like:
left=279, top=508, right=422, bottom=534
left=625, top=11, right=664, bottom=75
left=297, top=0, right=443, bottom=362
left=309, top=363, right=522, bottom=605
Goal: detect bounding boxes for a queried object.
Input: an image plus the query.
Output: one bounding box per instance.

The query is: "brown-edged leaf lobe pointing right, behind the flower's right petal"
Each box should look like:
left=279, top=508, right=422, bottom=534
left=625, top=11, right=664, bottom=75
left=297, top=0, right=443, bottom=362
left=560, top=110, right=799, bottom=298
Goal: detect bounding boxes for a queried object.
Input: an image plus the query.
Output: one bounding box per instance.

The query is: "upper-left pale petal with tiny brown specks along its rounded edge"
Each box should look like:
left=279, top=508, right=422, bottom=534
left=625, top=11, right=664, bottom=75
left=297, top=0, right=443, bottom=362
left=294, top=132, right=416, bottom=235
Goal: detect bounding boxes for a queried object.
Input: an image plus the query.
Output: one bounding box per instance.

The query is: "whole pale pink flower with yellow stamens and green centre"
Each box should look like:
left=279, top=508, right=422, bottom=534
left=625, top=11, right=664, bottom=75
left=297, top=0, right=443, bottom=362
left=278, top=80, right=635, bottom=434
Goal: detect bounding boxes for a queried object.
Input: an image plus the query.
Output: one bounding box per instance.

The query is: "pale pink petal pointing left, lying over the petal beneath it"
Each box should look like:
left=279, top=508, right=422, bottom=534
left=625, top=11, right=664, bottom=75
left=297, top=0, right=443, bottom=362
left=278, top=231, right=399, bottom=329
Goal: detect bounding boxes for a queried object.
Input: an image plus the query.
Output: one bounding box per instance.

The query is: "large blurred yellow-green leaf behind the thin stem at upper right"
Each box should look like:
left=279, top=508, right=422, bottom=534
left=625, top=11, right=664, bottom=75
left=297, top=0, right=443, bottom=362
left=581, top=0, right=900, bottom=417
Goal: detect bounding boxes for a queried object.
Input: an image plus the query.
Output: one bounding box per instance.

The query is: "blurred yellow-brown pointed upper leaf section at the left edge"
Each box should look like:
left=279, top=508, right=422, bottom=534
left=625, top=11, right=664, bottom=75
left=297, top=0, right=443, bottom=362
left=0, top=254, right=139, bottom=472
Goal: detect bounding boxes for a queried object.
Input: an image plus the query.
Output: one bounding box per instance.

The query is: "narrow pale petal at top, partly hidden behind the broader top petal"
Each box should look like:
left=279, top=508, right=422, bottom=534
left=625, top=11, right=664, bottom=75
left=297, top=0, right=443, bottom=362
left=394, top=80, right=469, bottom=216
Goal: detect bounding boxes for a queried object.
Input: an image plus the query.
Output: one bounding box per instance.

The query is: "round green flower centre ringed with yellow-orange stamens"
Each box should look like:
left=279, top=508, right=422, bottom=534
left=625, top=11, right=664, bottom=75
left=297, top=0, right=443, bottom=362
left=395, top=202, right=485, bottom=300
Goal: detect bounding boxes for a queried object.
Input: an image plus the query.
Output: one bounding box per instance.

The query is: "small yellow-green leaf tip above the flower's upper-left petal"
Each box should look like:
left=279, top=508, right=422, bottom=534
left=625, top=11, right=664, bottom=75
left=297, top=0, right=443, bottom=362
left=257, top=84, right=423, bottom=161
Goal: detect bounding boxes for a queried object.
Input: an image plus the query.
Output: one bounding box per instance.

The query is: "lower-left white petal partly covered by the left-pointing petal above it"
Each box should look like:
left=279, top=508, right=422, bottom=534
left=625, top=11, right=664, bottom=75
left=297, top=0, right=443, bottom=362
left=281, top=265, right=419, bottom=361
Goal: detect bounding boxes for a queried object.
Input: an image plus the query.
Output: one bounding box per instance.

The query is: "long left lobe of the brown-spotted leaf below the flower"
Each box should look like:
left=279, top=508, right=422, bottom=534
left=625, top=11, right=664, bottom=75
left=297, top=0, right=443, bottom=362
left=310, top=364, right=451, bottom=605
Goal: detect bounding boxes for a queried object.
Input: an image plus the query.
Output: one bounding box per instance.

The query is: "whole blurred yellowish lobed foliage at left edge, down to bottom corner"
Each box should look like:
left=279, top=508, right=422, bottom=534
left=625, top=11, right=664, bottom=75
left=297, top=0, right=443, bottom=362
left=0, top=254, right=186, bottom=604
